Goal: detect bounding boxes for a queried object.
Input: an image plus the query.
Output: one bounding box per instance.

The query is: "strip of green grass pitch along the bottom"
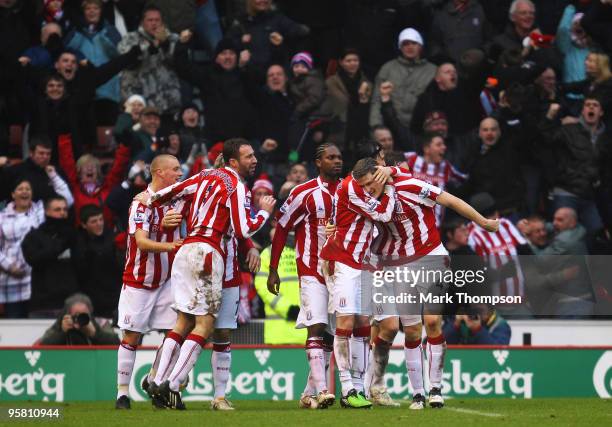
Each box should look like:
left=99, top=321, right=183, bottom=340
left=0, top=399, right=612, bottom=427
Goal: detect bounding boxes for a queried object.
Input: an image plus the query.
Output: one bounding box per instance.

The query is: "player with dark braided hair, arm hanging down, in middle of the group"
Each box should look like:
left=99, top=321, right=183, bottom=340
left=268, top=144, right=342, bottom=408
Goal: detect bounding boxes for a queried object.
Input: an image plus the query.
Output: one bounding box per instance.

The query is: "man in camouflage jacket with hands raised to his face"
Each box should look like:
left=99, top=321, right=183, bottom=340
left=117, top=6, right=181, bottom=115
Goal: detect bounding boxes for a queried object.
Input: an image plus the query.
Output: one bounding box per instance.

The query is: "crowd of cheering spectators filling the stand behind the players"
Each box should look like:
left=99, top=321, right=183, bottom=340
left=0, top=0, right=612, bottom=320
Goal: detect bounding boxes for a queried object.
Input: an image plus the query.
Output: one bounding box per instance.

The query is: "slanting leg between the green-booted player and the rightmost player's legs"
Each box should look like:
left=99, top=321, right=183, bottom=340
left=366, top=316, right=399, bottom=406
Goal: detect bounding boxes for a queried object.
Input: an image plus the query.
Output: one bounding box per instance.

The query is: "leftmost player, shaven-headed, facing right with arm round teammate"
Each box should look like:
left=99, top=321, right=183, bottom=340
left=115, top=154, right=185, bottom=409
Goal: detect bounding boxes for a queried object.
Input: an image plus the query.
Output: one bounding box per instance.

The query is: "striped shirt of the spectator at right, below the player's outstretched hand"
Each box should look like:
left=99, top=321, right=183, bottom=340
left=468, top=218, right=527, bottom=296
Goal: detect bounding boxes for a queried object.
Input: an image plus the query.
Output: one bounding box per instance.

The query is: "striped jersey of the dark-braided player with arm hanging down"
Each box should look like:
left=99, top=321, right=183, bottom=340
left=270, top=177, right=340, bottom=283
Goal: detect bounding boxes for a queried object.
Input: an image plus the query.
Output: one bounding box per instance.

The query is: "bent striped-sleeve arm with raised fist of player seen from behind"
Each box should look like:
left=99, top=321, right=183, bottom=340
left=229, top=181, right=276, bottom=239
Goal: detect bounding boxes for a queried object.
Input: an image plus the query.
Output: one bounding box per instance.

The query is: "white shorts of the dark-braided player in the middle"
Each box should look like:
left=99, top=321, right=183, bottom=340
left=295, top=276, right=329, bottom=329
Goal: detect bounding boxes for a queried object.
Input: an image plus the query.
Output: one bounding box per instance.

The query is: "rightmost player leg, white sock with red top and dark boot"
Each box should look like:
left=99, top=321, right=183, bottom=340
left=423, top=314, right=446, bottom=408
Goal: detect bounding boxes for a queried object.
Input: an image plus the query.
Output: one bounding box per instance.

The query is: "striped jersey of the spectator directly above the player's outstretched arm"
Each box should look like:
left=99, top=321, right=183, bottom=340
left=404, top=151, right=468, bottom=227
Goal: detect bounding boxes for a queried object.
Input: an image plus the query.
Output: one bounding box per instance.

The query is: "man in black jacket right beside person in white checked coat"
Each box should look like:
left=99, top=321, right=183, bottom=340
left=21, top=196, right=78, bottom=318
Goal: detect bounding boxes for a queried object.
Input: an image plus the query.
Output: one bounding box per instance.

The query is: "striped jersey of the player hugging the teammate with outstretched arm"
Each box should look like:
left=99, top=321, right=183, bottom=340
left=321, top=175, right=395, bottom=269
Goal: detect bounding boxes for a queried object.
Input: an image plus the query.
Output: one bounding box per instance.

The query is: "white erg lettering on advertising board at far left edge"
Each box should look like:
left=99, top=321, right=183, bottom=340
left=0, top=368, right=65, bottom=402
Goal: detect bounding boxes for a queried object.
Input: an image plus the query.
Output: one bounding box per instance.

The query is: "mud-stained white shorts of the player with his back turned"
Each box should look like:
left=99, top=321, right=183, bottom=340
left=172, top=242, right=225, bottom=317
